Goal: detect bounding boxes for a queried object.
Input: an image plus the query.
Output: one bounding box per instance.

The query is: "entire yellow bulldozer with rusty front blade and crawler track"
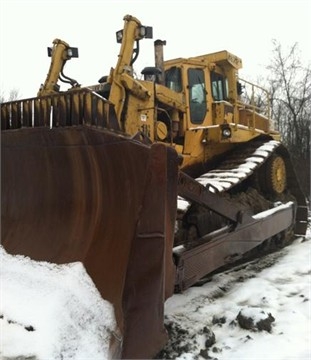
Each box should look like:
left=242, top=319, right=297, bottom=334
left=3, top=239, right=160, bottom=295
left=1, top=15, right=308, bottom=359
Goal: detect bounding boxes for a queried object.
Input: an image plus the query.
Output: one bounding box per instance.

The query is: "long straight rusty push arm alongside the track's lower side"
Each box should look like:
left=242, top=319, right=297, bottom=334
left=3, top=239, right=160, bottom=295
left=175, top=202, right=294, bottom=291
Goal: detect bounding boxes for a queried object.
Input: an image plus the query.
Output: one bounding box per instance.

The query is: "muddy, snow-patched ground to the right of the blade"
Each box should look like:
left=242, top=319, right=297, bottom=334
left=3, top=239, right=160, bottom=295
left=160, top=232, right=311, bottom=360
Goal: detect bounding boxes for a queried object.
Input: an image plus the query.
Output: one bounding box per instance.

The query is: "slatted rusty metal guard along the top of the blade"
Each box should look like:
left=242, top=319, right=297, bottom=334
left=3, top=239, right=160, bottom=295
left=1, top=88, right=119, bottom=130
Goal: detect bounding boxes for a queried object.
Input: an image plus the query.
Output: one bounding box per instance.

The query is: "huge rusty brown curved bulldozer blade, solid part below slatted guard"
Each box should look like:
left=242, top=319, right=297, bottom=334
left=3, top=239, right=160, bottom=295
left=1, top=125, right=178, bottom=358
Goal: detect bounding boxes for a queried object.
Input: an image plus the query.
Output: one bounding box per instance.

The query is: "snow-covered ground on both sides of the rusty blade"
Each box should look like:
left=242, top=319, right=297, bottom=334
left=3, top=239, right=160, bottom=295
left=0, top=231, right=311, bottom=360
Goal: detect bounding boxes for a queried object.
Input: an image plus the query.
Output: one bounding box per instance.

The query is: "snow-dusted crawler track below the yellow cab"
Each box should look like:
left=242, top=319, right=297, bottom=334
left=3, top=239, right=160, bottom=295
left=175, top=139, right=308, bottom=247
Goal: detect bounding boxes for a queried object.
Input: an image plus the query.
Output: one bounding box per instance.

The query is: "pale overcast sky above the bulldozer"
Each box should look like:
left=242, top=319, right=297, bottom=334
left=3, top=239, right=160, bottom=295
left=0, top=0, right=311, bottom=98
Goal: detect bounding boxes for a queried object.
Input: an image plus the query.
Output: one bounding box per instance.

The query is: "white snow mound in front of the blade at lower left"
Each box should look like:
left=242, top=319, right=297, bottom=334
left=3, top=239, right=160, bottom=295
left=0, top=247, right=116, bottom=360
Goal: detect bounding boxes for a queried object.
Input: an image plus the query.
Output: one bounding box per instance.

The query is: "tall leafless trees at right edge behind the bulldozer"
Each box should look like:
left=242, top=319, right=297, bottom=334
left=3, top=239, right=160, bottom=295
left=267, top=40, right=311, bottom=201
